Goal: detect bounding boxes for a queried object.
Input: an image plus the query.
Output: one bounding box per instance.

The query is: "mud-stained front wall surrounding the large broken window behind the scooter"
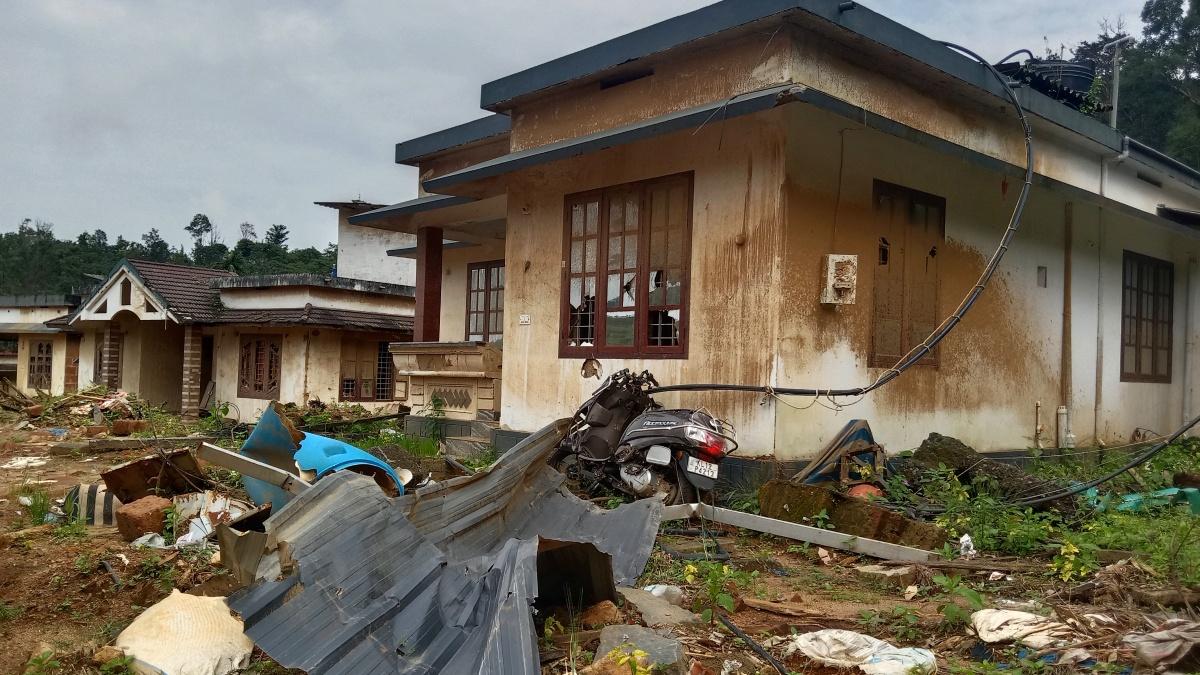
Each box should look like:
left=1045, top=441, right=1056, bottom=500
left=502, top=110, right=784, bottom=452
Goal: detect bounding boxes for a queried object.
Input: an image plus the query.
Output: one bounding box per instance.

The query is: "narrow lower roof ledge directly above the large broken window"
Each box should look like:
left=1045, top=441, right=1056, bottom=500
left=424, top=83, right=805, bottom=192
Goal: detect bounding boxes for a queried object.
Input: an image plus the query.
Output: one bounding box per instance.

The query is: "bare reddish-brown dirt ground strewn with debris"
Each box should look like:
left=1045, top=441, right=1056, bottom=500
left=0, top=415, right=1185, bottom=675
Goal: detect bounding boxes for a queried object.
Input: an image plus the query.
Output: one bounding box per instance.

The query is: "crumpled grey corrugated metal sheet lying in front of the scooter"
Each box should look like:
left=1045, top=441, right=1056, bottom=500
left=229, top=420, right=662, bottom=674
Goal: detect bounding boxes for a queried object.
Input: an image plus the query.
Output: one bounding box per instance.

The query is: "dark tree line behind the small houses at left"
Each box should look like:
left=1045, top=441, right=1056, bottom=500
left=0, top=214, right=337, bottom=295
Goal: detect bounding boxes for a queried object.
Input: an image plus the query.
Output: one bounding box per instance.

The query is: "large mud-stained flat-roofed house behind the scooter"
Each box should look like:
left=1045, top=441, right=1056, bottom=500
left=347, top=0, right=1200, bottom=459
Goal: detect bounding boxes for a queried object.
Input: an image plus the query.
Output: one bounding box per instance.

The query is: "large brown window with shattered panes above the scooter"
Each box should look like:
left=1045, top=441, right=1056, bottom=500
left=559, top=173, right=692, bottom=358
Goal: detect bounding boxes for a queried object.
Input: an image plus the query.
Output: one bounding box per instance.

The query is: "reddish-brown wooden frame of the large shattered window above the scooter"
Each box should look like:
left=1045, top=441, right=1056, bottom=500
left=558, top=172, right=695, bottom=359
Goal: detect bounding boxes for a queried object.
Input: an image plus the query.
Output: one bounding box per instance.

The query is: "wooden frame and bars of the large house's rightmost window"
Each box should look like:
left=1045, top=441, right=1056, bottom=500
left=1121, top=251, right=1175, bottom=384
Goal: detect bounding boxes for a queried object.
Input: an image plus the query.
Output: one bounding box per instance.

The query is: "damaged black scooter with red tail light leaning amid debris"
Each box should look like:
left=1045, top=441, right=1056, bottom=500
left=551, top=370, right=738, bottom=504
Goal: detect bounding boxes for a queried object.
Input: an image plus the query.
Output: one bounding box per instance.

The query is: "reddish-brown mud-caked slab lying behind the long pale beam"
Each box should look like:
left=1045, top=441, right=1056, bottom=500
left=758, top=479, right=948, bottom=550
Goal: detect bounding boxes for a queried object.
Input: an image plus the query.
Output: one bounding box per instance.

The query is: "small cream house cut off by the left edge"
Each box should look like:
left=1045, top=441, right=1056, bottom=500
left=0, top=293, right=79, bottom=395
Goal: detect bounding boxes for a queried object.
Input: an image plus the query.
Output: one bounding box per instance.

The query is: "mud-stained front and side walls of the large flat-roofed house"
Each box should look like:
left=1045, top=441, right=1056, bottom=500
left=489, top=99, right=1200, bottom=459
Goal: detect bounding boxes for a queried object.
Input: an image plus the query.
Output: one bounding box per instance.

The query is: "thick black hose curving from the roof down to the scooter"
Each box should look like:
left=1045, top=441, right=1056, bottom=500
left=649, top=42, right=1033, bottom=396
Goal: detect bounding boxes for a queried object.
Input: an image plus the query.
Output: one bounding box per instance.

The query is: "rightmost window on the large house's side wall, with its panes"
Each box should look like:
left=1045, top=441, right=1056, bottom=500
left=1121, top=251, right=1175, bottom=382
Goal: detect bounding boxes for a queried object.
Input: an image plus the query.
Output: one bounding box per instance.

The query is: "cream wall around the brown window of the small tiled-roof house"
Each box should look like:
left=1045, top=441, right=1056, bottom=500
left=205, top=327, right=396, bottom=422
